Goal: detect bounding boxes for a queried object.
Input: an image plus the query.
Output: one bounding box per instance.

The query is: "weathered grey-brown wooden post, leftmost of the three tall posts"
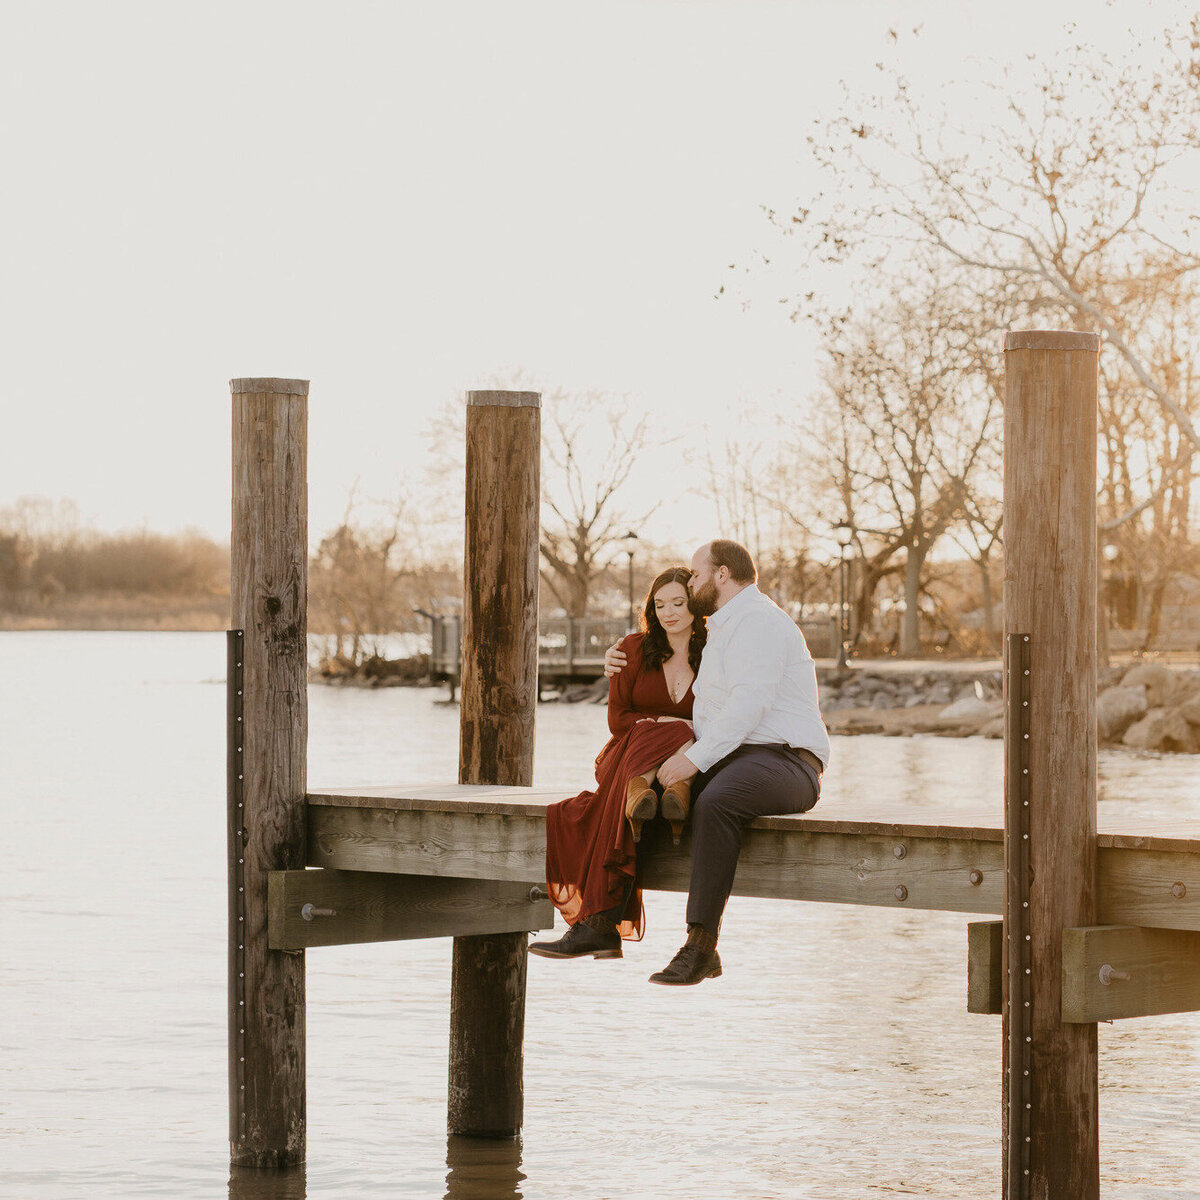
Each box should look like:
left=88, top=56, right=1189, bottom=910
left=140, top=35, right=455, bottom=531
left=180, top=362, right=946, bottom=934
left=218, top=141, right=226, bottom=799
left=229, top=379, right=308, bottom=1166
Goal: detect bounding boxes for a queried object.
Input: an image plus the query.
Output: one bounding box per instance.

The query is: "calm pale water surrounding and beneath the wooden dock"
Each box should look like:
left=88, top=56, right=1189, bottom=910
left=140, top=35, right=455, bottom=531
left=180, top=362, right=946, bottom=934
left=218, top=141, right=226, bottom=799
left=0, top=634, right=1200, bottom=1200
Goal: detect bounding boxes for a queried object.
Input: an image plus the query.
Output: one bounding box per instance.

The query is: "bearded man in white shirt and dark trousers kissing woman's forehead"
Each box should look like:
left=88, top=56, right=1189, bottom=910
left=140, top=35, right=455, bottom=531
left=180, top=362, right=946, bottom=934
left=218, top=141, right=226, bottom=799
left=605, top=539, right=829, bottom=985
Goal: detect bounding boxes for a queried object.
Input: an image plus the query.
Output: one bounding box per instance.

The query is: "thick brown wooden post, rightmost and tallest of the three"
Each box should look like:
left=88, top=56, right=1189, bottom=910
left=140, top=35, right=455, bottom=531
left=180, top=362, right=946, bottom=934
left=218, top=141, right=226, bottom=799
left=1004, top=332, right=1099, bottom=1200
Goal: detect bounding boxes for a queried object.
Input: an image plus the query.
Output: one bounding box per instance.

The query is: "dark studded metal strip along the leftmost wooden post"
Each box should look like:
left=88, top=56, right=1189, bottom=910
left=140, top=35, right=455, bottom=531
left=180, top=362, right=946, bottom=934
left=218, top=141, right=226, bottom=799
left=226, top=629, right=246, bottom=1142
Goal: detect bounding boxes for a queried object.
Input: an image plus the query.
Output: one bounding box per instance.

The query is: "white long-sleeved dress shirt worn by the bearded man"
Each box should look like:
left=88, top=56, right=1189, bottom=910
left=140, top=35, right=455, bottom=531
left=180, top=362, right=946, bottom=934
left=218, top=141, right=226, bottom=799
left=685, top=583, right=829, bottom=770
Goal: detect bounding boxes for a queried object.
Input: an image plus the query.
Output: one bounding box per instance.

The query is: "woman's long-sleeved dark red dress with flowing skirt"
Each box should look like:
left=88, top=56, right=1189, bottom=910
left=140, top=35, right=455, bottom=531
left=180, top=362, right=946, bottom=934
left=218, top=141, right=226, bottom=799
left=546, top=634, right=692, bottom=941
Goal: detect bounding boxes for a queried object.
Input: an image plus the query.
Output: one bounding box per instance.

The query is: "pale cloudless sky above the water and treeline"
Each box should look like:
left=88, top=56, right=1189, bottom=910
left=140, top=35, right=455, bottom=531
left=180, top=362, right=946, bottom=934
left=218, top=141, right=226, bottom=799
left=0, top=0, right=1183, bottom=546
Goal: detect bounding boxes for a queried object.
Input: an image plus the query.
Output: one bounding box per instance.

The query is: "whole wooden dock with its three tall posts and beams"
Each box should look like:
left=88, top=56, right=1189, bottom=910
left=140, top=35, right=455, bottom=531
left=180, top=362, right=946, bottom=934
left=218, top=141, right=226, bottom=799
left=227, top=343, right=1200, bottom=1200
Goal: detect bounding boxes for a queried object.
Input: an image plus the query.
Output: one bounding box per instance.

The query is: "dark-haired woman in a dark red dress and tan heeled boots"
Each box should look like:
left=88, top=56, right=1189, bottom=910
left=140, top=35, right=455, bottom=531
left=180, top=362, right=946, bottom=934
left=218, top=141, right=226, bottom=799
left=529, top=566, right=706, bottom=959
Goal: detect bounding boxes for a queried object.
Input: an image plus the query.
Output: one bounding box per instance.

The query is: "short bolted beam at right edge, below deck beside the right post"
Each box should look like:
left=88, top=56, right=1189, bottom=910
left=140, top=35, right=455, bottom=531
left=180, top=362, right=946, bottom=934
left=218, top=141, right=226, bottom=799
left=1062, top=925, right=1200, bottom=1024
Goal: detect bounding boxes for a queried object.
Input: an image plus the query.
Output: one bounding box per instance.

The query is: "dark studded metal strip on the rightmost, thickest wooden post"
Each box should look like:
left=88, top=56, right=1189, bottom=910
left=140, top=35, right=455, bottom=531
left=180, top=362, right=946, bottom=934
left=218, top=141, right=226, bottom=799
left=1004, top=634, right=1033, bottom=1200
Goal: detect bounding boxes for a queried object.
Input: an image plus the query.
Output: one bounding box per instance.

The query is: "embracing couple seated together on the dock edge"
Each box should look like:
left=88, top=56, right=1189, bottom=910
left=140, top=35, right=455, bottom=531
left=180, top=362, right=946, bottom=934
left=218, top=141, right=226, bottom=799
left=529, top=540, right=829, bottom=985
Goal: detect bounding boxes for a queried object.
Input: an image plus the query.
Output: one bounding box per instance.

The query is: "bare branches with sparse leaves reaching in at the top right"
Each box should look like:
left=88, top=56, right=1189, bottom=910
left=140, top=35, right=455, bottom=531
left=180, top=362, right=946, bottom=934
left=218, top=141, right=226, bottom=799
left=770, top=17, right=1200, bottom=468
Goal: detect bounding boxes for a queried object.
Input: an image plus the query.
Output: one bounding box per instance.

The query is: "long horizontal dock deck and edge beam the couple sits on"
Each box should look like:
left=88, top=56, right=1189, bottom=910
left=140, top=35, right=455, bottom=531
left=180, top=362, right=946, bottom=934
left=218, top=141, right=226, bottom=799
left=308, top=785, right=1200, bottom=930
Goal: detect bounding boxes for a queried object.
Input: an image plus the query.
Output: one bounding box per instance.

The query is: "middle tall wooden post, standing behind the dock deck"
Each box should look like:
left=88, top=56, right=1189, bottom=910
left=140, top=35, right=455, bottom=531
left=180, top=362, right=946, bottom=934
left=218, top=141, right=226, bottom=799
left=448, top=391, right=541, bottom=1138
